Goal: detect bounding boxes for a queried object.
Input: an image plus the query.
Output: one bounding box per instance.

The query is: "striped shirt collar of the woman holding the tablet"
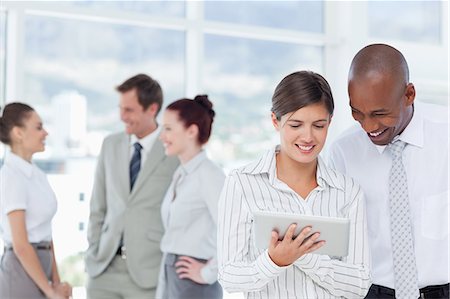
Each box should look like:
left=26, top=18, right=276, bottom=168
left=242, top=145, right=344, bottom=190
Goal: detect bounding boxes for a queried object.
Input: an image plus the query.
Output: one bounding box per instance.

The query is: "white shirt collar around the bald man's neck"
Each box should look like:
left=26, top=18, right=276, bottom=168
left=375, top=105, right=424, bottom=154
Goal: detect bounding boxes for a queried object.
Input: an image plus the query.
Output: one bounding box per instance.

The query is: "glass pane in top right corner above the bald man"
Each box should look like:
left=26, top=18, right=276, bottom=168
left=368, top=1, right=442, bottom=43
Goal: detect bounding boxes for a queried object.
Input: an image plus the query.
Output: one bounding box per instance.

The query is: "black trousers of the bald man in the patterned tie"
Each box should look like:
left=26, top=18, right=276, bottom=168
left=365, top=283, right=450, bottom=299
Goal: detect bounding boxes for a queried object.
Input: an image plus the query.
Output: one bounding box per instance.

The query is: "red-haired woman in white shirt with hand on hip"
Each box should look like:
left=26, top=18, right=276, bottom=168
left=157, top=96, right=225, bottom=299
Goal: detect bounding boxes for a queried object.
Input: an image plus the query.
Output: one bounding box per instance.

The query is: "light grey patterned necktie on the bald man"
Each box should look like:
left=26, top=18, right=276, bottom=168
left=389, top=140, right=420, bottom=299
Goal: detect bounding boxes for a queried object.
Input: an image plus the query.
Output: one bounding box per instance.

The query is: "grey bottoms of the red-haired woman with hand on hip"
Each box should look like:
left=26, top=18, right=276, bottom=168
left=163, top=253, right=223, bottom=299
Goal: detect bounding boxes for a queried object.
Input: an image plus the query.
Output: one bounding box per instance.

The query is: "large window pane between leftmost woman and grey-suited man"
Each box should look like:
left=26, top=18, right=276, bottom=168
left=23, top=16, right=185, bottom=285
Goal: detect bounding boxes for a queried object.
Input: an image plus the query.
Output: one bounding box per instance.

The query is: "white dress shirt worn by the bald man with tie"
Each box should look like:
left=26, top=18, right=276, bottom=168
left=330, top=104, right=449, bottom=289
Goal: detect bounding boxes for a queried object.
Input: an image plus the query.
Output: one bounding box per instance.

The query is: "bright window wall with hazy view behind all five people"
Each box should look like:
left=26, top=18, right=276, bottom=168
left=0, top=1, right=449, bottom=298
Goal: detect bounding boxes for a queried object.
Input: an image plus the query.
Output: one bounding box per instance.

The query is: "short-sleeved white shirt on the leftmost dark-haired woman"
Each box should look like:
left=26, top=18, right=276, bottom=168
left=0, top=151, right=57, bottom=246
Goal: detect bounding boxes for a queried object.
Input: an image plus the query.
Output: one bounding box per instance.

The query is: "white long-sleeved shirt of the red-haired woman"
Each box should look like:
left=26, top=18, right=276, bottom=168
left=161, top=151, right=225, bottom=284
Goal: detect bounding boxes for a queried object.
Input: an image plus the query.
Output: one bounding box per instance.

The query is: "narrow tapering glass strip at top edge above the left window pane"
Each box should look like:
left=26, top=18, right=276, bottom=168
left=70, top=0, right=185, bottom=17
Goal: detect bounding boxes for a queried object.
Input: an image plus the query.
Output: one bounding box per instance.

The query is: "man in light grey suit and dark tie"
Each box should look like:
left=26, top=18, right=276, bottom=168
left=86, top=74, right=178, bottom=299
